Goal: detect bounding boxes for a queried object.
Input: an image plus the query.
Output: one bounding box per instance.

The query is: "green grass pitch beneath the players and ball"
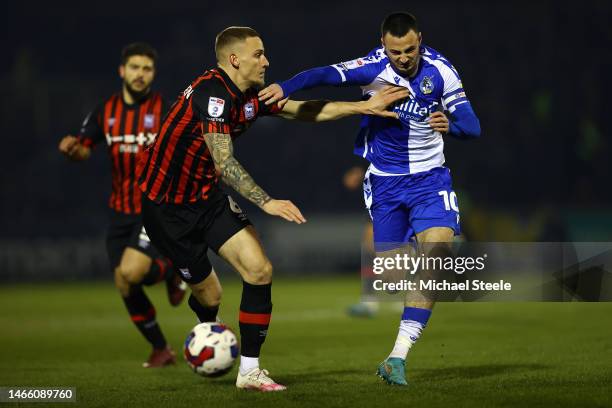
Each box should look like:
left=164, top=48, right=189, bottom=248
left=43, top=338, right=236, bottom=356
left=0, top=277, right=612, bottom=408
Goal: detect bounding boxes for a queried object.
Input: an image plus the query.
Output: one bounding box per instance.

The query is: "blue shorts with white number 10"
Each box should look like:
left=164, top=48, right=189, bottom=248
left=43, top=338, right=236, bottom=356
left=363, top=167, right=461, bottom=245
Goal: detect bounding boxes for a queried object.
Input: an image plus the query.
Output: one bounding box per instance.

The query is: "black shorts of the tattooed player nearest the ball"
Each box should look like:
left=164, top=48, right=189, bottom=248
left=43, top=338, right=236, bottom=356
left=142, top=189, right=251, bottom=284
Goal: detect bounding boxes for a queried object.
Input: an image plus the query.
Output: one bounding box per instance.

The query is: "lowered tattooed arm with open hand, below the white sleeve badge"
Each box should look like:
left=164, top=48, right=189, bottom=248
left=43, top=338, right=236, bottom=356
left=204, top=133, right=306, bottom=224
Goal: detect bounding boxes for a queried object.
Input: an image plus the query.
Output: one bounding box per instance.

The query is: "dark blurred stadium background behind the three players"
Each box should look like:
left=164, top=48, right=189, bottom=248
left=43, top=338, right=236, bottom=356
left=0, top=0, right=612, bottom=280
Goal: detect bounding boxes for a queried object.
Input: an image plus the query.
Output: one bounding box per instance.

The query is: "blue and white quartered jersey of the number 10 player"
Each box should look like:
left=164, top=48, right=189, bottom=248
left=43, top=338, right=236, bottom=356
left=332, top=46, right=468, bottom=175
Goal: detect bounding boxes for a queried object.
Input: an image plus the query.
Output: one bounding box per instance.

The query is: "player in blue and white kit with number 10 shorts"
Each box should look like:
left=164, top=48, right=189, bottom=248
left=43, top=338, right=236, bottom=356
left=259, top=12, right=480, bottom=385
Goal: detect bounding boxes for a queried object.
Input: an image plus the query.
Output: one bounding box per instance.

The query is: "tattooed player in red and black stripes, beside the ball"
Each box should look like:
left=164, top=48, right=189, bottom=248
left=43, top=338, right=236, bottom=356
left=139, top=27, right=408, bottom=391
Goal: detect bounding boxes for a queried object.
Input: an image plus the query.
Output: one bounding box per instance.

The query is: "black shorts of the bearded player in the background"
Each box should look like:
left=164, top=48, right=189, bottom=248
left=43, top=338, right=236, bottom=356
left=106, top=210, right=160, bottom=270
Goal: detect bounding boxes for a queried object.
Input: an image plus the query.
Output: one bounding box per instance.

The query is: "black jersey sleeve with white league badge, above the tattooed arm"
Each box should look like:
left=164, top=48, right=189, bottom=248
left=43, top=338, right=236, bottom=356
left=191, top=81, right=232, bottom=134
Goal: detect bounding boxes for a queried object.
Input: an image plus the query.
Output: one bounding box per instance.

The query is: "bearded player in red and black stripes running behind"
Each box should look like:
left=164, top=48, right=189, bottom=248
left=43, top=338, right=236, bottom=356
left=59, top=43, right=186, bottom=367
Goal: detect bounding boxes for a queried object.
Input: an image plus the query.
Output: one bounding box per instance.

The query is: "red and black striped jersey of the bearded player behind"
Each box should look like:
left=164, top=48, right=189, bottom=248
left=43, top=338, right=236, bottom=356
left=79, top=93, right=164, bottom=214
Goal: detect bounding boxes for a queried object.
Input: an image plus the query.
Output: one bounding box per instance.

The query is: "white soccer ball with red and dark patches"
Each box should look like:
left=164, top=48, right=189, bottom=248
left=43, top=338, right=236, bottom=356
left=183, top=323, right=239, bottom=377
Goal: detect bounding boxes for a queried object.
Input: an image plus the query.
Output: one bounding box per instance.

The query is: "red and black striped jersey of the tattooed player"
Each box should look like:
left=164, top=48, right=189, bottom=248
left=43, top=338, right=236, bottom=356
left=139, top=68, right=280, bottom=204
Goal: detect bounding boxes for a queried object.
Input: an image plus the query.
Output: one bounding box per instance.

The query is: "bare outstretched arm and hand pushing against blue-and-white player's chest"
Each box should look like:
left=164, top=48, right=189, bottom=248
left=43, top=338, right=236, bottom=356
left=279, top=86, right=410, bottom=122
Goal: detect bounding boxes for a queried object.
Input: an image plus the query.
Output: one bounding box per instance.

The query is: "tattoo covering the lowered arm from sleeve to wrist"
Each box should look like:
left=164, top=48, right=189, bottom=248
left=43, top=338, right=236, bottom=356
left=204, top=133, right=271, bottom=207
